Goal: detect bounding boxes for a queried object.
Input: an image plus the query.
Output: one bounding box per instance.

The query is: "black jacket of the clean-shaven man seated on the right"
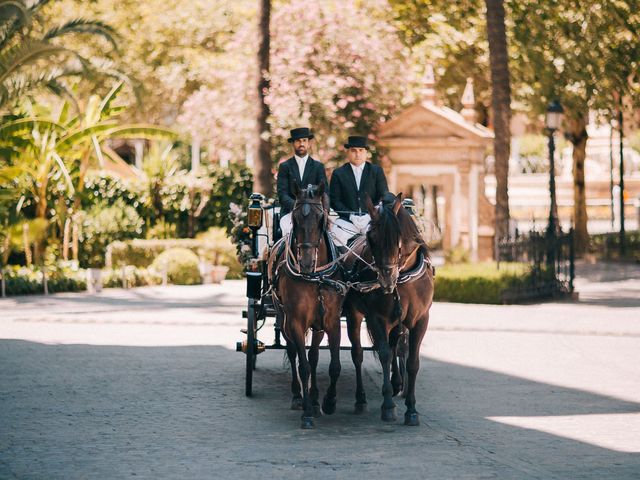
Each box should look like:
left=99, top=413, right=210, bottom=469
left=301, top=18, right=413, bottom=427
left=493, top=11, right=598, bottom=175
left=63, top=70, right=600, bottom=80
left=329, top=162, right=389, bottom=220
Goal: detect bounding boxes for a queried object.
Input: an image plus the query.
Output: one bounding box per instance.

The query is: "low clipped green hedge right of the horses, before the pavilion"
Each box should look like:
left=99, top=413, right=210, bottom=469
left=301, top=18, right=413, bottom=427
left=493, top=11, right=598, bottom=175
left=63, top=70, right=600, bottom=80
left=434, top=263, right=530, bottom=304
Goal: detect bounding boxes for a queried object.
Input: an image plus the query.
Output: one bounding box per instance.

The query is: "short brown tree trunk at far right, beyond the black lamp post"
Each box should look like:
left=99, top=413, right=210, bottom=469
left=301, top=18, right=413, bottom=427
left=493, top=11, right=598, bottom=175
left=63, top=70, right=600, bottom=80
left=566, top=115, right=589, bottom=255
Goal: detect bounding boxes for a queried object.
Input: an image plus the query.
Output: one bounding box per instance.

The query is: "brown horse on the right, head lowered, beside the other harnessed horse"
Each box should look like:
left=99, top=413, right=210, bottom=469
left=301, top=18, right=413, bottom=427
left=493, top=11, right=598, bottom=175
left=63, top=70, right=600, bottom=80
left=344, top=194, right=434, bottom=425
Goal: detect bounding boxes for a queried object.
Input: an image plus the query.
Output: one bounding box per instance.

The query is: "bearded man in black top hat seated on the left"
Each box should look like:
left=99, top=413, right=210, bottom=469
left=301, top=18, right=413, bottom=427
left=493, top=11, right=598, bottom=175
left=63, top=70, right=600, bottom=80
left=278, top=127, right=327, bottom=235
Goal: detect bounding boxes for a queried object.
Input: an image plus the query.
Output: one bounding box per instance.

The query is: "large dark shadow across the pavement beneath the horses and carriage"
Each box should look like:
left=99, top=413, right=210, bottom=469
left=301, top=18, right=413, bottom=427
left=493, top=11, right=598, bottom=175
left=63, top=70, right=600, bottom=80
left=0, top=340, right=640, bottom=479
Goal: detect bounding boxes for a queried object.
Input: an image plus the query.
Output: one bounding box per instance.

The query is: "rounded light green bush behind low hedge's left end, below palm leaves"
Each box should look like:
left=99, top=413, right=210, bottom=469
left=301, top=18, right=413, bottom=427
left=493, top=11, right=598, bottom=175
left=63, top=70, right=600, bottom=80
left=78, top=199, right=144, bottom=268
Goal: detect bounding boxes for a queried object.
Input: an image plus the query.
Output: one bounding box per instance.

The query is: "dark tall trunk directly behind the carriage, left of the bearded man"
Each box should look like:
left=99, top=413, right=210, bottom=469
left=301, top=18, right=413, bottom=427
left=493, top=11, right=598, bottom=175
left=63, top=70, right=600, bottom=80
left=253, top=0, right=272, bottom=196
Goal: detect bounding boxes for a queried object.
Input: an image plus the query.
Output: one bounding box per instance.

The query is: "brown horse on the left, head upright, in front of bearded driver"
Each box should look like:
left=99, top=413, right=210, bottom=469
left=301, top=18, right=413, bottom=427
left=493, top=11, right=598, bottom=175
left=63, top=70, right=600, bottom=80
left=268, top=184, right=346, bottom=428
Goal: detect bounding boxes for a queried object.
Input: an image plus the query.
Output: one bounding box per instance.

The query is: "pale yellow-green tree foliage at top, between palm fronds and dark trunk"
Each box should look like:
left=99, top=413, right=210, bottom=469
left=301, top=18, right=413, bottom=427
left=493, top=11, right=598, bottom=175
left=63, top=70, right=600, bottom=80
left=44, top=0, right=256, bottom=125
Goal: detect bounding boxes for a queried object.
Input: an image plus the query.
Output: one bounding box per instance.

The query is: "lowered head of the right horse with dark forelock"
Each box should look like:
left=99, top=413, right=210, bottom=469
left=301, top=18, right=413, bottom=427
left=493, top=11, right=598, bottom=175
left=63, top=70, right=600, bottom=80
left=365, top=193, right=402, bottom=293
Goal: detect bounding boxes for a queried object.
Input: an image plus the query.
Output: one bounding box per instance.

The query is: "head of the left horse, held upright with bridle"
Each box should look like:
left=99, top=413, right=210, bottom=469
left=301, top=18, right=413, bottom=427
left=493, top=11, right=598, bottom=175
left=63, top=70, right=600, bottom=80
left=291, top=183, right=328, bottom=273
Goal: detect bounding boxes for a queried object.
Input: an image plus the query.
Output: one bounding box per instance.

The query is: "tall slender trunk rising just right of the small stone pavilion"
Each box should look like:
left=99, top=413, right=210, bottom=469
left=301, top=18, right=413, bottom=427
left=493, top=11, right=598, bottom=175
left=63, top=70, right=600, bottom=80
left=485, top=0, right=511, bottom=240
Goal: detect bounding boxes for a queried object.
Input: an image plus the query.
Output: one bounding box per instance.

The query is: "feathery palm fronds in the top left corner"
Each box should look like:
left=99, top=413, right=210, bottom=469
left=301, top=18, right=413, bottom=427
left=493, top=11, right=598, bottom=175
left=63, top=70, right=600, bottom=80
left=0, top=0, right=119, bottom=109
